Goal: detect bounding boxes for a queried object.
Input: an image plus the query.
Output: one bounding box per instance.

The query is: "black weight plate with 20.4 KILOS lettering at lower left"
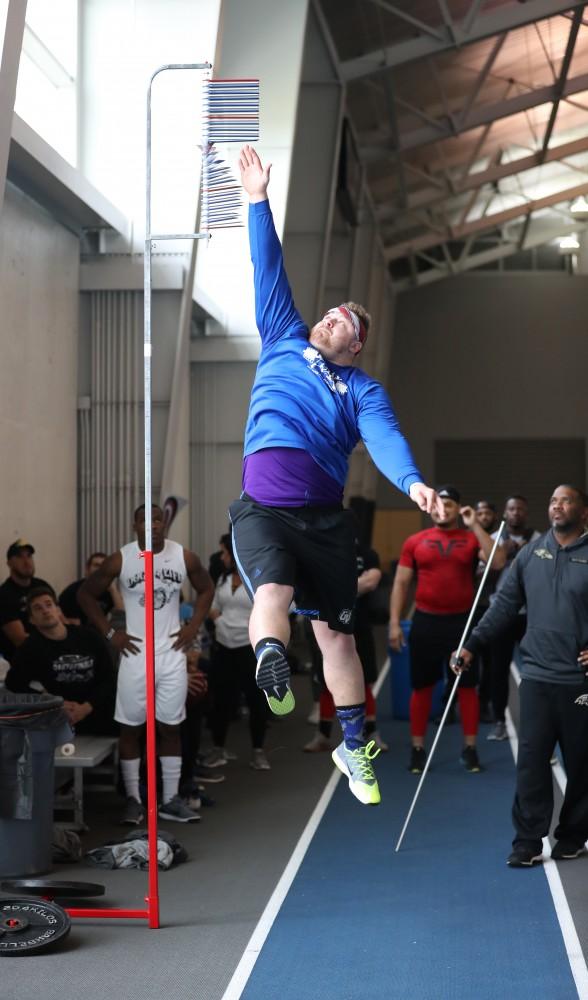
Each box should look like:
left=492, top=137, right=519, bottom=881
left=0, top=898, right=71, bottom=957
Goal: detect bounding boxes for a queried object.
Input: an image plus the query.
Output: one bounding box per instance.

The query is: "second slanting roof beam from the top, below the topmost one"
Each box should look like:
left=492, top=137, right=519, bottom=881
left=359, top=73, right=588, bottom=158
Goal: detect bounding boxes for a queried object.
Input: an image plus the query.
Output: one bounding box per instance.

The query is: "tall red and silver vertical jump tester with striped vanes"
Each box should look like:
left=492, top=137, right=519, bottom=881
left=0, top=63, right=259, bottom=955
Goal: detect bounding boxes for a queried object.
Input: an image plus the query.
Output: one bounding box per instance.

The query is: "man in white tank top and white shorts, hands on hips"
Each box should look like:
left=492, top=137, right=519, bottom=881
left=78, top=504, right=214, bottom=825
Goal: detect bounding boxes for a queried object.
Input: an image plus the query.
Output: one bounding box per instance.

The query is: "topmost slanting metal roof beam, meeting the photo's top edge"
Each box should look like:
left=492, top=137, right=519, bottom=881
left=341, top=0, right=584, bottom=81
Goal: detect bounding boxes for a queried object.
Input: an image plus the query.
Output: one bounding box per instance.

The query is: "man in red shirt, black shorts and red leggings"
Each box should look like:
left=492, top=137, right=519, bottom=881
left=390, top=486, right=503, bottom=774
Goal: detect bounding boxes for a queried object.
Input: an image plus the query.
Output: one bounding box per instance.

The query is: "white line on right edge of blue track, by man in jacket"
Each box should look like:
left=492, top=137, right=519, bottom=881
left=506, top=663, right=588, bottom=1000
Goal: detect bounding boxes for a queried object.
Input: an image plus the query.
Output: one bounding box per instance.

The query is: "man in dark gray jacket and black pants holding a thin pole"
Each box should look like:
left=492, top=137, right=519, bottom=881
left=452, top=484, right=588, bottom=868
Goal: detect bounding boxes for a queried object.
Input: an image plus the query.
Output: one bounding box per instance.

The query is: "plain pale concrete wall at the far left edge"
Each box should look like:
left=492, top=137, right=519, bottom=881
left=0, top=185, right=79, bottom=588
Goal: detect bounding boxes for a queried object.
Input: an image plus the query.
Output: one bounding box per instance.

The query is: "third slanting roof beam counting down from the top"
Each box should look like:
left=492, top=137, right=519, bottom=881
left=377, top=135, right=588, bottom=222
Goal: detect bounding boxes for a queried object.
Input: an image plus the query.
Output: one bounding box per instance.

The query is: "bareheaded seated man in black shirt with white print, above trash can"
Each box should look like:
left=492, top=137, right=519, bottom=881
left=5, top=585, right=117, bottom=736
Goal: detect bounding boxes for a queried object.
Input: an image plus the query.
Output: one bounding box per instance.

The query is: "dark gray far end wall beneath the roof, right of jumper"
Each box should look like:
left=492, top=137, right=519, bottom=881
left=378, top=272, right=588, bottom=507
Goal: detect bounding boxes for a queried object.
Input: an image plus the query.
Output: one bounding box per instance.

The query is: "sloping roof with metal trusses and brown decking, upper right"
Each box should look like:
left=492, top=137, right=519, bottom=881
left=314, top=0, right=588, bottom=289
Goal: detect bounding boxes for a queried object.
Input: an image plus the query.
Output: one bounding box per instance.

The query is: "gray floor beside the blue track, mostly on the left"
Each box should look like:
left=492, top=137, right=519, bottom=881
left=0, top=636, right=588, bottom=1000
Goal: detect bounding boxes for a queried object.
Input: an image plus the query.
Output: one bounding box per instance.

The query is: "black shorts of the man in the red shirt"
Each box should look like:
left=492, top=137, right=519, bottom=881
left=408, top=611, right=478, bottom=691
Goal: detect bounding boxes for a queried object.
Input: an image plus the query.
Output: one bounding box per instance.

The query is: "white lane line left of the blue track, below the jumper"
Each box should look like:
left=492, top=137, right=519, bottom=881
left=222, top=659, right=390, bottom=1000
